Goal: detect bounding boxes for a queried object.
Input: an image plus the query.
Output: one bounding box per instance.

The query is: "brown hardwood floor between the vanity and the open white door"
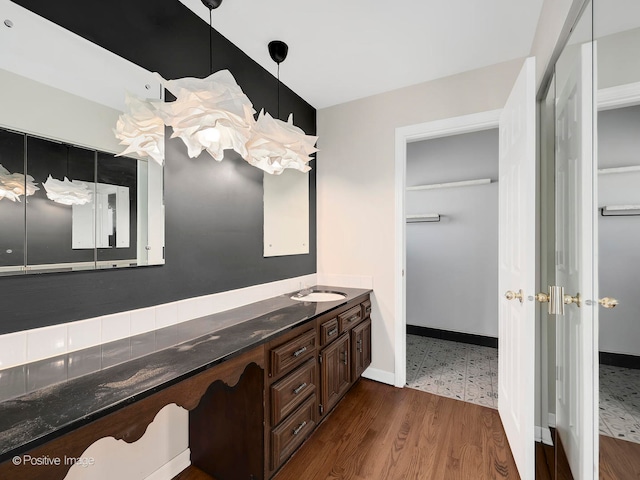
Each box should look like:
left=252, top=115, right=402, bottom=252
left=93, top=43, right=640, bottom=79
left=274, top=379, right=520, bottom=480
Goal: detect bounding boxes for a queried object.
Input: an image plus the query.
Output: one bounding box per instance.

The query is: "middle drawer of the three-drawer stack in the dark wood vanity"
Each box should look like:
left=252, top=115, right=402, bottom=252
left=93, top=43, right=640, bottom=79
left=271, top=356, right=318, bottom=425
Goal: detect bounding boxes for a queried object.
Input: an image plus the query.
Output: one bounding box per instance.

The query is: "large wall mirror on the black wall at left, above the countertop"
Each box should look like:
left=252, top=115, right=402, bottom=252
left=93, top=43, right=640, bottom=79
left=0, top=0, right=164, bottom=275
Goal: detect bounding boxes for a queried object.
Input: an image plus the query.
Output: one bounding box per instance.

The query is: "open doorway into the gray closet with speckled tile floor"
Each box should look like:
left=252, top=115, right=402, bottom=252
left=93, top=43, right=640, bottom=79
left=406, top=128, right=499, bottom=408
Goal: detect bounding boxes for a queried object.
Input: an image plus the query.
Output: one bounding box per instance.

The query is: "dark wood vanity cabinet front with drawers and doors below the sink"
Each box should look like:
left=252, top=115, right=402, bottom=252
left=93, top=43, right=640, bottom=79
left=265, top=296, right=371, bottom=478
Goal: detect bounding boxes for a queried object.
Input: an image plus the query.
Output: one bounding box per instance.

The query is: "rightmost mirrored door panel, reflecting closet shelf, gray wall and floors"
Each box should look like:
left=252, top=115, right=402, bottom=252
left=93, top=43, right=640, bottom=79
left=593, top=0, right=640, bottom=479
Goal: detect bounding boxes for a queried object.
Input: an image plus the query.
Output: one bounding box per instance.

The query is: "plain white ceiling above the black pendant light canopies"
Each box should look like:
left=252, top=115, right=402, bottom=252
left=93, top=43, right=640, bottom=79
left=180, top=0, right=543, bottom=109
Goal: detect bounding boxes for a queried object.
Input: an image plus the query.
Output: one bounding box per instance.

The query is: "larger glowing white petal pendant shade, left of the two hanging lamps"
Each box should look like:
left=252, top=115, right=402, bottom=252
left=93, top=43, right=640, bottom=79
left=160, top=70, right=255, bottom=161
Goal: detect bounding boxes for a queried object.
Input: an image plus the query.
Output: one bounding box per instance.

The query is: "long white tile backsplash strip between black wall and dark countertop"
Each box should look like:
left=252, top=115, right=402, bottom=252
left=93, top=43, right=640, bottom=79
left=0, top=273, right=318, bottom=370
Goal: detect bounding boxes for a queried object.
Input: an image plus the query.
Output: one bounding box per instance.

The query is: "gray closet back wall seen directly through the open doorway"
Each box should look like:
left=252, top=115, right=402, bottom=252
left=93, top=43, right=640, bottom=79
left=407, top=129, right=498, bottom=337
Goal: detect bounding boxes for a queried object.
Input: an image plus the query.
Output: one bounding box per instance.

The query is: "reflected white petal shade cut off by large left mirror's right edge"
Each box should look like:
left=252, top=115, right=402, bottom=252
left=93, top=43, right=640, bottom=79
left=114, top=92, right=164, bottom=165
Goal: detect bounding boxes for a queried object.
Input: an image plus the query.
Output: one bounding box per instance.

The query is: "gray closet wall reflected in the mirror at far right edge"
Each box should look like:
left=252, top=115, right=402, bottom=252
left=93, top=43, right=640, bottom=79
left=598, top=106, right=640, bottom=355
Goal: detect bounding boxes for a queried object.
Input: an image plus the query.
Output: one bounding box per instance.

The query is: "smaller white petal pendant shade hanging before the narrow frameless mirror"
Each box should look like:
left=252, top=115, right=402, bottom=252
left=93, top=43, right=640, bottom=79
left=245, top=110, right=318, bottom=175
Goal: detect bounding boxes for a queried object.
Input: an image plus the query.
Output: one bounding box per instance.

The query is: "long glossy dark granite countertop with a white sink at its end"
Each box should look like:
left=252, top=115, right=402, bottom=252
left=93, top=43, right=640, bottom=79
left=0, top=286, right=371, bottom=462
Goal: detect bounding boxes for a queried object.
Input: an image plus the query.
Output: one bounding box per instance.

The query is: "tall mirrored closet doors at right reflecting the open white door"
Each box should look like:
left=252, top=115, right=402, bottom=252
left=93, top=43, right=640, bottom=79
left=541, top=0, right=640, bottom=480
